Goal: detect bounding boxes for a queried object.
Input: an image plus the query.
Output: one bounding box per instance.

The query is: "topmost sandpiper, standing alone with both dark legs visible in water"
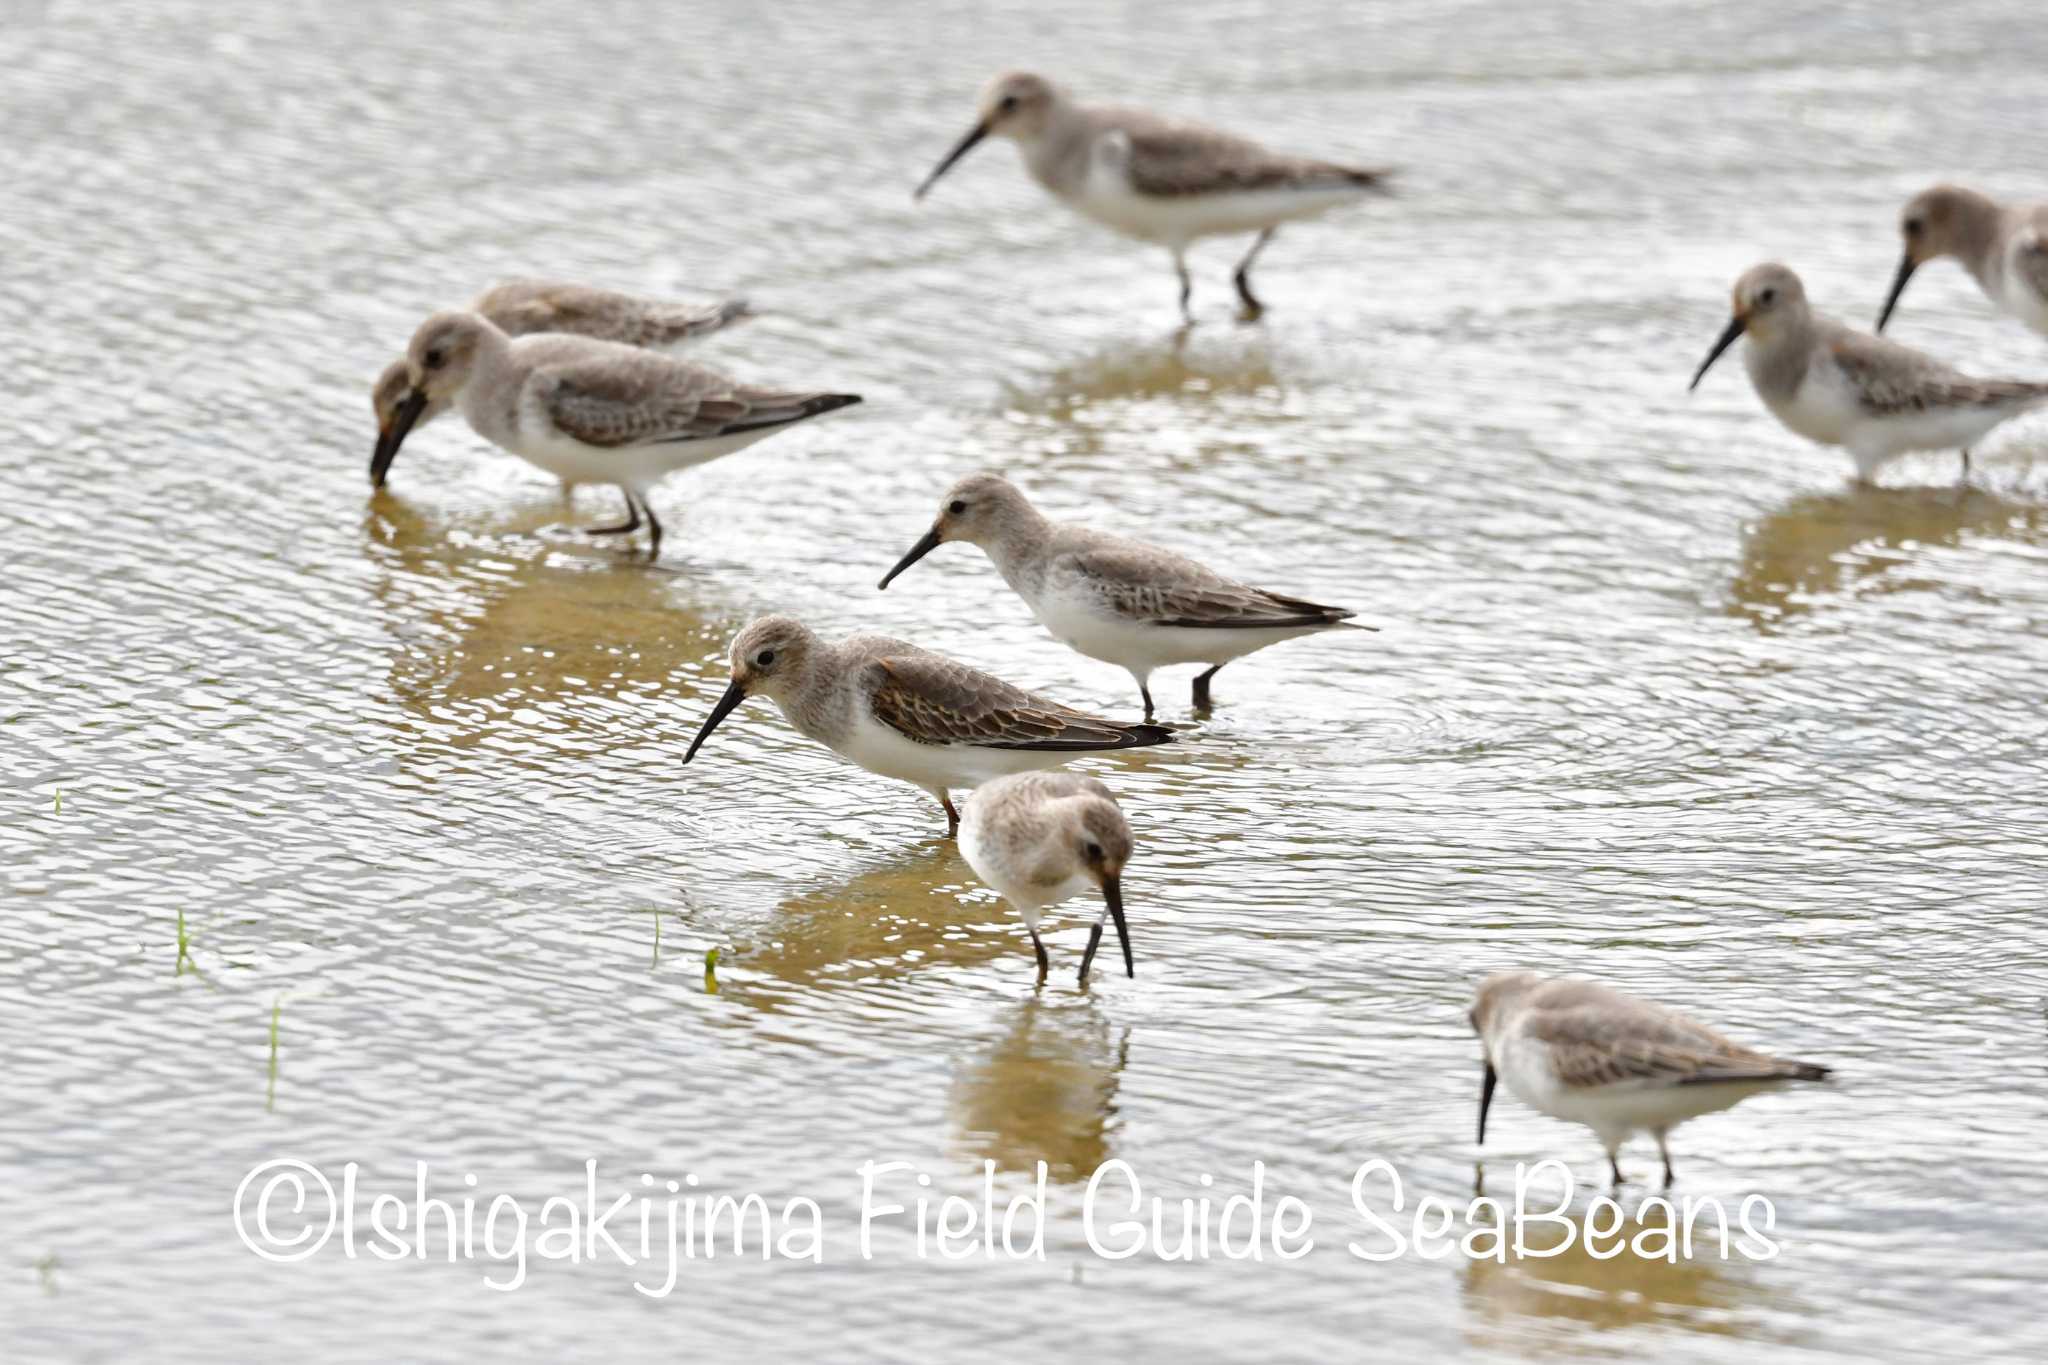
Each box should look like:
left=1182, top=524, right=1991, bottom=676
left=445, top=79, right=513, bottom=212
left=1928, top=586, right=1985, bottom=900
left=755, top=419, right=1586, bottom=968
left=913, top=72, right=1389, bottom=321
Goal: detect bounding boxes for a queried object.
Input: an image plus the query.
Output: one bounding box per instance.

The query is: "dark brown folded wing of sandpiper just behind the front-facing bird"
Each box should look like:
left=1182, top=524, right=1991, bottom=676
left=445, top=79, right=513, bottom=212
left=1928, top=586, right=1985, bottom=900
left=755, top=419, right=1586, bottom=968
left=868, top=655, right=1141, bottom=749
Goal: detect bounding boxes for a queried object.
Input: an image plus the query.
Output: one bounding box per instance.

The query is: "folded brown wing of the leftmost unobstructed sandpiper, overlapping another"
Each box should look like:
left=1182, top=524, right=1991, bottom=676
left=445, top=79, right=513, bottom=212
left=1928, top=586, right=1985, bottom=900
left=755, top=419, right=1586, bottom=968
left=545, top=354, right=823, bottom=446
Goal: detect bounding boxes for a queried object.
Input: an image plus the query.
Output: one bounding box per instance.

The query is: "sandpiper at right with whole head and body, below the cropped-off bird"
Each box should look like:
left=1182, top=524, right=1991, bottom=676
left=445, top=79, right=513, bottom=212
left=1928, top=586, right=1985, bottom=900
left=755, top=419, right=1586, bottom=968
left=1688, top=262, right=2048, bottom=483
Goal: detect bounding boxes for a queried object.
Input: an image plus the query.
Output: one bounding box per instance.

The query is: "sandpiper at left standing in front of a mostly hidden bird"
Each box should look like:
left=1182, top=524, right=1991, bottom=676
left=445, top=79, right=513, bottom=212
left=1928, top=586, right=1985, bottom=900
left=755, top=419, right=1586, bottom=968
left=371, top=313, right=860, bottom=559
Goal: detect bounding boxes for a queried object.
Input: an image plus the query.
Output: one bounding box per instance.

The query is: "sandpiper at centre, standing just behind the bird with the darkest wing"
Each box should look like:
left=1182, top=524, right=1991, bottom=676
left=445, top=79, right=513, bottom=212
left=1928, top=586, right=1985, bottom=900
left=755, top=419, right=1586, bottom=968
left=881, top=475, right=1372, bottom=720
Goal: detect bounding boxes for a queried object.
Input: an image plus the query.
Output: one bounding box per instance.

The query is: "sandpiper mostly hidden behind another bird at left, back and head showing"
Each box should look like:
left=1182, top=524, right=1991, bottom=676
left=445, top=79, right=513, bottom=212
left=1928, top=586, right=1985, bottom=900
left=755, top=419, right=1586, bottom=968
left=371, top=280, right=754, bottom=487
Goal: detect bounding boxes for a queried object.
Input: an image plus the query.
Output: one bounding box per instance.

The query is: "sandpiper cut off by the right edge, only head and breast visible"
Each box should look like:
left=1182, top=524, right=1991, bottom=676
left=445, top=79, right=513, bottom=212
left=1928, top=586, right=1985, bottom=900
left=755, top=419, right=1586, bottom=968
left=1878, top=184, right=2048, bottom=336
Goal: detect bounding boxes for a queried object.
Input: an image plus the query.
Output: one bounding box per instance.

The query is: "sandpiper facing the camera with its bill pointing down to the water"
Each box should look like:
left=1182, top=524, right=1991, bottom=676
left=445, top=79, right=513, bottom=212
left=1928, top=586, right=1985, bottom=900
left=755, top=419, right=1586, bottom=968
left=961, top=772, right=1137, bottom=984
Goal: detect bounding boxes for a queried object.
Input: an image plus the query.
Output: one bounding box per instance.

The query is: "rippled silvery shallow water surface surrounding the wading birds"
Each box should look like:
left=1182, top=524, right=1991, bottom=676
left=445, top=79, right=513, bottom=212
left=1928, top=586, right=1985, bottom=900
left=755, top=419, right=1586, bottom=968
left=0, top=0, right=2048, bottom=1361
